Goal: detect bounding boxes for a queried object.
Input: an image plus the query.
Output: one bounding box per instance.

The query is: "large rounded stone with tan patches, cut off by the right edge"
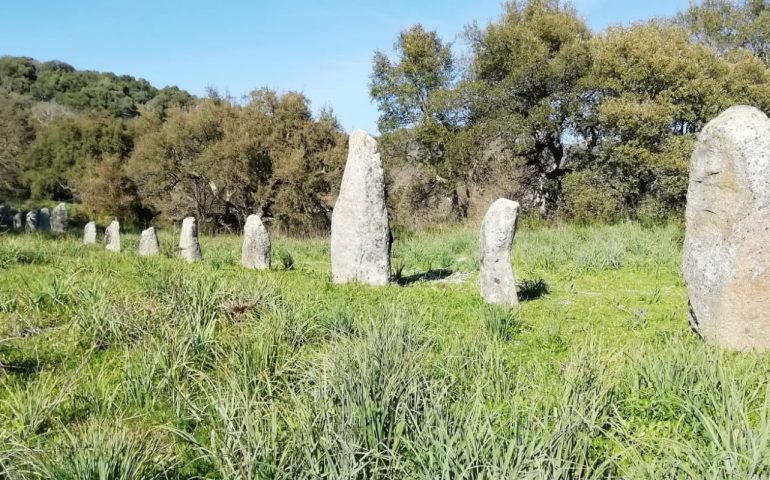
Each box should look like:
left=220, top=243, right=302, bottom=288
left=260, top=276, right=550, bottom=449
left=683, top=106, right=770, bottom=350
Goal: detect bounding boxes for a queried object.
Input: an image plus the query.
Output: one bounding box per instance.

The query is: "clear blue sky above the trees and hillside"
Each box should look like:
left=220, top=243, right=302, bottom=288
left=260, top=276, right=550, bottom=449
left=0, top=0, right=689, bottom=131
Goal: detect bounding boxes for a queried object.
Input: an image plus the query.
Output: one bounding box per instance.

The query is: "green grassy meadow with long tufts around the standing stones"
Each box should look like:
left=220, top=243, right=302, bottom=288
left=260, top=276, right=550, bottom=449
left=0, top=223, right=770, bottom=480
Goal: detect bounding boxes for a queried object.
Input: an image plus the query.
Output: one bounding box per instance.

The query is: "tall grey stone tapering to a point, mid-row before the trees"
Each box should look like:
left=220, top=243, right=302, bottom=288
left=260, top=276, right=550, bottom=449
left=331, top=130, right=390, bottom=286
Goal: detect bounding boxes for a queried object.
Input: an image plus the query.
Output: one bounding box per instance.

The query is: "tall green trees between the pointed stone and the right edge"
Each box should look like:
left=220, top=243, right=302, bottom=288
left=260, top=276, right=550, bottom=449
left=370, top=0, right=770, bottom=223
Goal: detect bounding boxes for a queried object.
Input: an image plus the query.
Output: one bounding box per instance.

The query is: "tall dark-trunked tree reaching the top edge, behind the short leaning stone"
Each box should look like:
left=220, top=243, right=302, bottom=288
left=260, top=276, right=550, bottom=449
left=468, top=0, right=591, bottom=213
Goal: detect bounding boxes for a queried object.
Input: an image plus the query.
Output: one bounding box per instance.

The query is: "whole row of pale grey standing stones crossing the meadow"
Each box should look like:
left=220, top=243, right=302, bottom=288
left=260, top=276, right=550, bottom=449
left=0, top=106, right=770, bottom=351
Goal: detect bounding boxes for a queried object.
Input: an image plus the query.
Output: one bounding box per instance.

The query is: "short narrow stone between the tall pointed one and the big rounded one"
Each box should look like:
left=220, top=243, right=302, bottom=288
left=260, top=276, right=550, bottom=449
left=479, top=198, right=519, bottom=305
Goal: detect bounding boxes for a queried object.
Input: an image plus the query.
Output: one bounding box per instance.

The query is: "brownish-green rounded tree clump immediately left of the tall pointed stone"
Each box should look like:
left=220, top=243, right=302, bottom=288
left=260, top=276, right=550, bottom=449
left=127, top=89, right=344, bottom=230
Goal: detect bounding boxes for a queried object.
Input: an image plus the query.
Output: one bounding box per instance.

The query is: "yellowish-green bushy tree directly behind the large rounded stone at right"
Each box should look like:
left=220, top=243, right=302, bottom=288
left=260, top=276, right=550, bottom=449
left=564, top=22, right=770, bottom=216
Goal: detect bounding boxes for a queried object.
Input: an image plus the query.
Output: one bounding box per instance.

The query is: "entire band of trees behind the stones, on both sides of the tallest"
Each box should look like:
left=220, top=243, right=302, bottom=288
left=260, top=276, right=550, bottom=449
left=0, top=0, right=770, bottom=233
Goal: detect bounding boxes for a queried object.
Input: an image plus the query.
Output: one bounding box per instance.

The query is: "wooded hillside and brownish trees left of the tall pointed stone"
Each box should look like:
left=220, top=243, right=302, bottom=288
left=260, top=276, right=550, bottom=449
left=0, top=57, right=346, bottom=233
